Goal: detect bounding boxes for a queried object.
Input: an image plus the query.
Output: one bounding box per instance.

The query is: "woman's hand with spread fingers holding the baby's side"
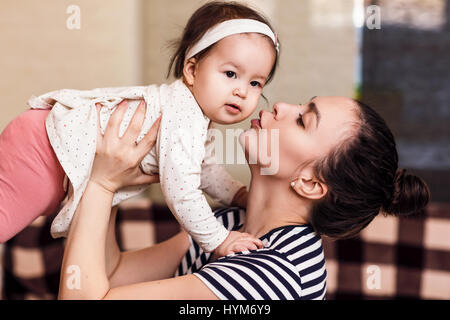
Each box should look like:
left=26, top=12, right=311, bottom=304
left=90, top=100, right=161, bottom=193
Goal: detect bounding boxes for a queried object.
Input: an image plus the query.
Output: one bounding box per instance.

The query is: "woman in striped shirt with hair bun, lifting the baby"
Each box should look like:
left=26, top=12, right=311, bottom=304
left=59, top=97, right=429, bottom=299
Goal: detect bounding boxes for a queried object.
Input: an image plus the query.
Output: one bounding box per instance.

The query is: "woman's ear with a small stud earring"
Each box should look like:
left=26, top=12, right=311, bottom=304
left=291, top=168, right=328, bottom=200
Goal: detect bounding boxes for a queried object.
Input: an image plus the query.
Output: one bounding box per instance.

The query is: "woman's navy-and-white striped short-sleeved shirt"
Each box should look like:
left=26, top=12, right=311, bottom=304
left=175, top=208, right=327, bottom=300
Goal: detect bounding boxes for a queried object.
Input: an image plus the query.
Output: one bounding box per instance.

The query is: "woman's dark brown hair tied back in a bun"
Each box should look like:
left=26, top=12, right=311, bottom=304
left=311, top=101, right=430, bottom=239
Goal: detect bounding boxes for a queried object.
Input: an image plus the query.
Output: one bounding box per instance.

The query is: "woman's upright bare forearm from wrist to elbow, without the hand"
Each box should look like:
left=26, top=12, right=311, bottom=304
left=58, top=182, right=113, bottom=299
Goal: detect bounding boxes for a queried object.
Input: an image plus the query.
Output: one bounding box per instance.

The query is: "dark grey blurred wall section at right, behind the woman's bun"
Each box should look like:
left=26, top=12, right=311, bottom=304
left=362, top=0, right=450, bottom=202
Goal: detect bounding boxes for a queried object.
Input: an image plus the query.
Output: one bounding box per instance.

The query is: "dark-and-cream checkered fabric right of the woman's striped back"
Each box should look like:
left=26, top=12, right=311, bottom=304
left=324, top=203, right=450, bottom=299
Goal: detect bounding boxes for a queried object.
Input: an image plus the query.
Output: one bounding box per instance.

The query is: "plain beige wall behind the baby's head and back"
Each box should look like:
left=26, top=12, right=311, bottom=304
left=0, top=0, right=356, bottom=199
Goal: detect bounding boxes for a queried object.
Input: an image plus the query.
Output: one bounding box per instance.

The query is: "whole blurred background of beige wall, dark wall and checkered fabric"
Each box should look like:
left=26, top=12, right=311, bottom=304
left=0, top=0, right=450, bottom=299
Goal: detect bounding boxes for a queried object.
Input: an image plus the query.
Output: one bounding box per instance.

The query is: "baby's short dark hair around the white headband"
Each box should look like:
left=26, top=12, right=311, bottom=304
left=167, top=1, right=278, bottom=83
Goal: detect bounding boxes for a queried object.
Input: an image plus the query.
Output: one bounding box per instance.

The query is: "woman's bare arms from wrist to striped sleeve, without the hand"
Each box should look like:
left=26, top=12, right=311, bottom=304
left=59, top=183, right=209, bottom=299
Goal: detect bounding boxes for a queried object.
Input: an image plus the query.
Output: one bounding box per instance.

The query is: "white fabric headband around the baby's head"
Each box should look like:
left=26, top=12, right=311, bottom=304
left=185, top=19, right=279, bottom=61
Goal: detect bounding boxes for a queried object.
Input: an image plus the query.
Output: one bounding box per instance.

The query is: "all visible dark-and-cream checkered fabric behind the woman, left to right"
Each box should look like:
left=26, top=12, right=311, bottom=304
left=3, top=199, right=450, bottom=299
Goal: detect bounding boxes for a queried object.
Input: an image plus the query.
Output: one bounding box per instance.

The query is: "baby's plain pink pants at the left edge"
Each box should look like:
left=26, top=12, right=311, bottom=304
left=0, top=109, right=65, bottom=243
